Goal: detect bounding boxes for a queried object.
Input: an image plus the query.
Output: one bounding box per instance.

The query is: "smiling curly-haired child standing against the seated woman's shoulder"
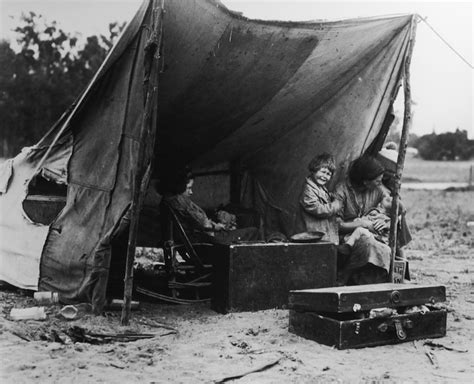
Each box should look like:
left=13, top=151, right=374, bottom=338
left=299, top=153, right=342, bottom=244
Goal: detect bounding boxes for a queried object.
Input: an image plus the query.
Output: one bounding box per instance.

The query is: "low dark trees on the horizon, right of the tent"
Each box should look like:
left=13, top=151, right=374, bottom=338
left=414, top=129, right=474, bottom=160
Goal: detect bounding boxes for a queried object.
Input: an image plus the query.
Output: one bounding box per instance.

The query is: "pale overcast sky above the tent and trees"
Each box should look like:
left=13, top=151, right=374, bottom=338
left=0, top=0, right=474, bottom=139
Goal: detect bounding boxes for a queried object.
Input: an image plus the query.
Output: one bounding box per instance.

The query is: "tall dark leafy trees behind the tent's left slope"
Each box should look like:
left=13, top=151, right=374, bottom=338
left=0, top=12, right=124, bottom=157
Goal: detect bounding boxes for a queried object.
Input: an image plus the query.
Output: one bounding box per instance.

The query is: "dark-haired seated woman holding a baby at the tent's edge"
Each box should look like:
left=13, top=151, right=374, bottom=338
left=336, top=156, right=390, bottom=285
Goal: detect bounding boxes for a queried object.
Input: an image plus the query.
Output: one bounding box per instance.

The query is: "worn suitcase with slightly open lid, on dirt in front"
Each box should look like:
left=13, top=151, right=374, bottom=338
left=289, top=283, right=446, bottom=349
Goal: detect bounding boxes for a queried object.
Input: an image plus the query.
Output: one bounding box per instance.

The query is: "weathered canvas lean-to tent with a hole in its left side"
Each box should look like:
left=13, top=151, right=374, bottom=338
left=0, top=0, right=414, bottom=308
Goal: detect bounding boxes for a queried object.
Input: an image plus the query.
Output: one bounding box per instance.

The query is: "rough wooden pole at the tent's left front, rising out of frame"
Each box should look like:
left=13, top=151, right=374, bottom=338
left=121, top=3, right=163, bottom=325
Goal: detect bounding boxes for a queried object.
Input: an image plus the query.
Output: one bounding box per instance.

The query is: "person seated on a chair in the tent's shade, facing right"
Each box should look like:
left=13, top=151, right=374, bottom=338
left=161, top=171, right=259, bottom=245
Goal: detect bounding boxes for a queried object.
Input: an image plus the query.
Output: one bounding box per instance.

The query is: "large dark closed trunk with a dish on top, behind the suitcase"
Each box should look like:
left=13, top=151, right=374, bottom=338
left=212, top=242, right=337, bottom=313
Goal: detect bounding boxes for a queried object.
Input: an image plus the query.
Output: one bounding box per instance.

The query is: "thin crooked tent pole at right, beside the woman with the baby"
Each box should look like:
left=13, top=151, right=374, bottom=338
left=389, top=15, right=416, bottom=283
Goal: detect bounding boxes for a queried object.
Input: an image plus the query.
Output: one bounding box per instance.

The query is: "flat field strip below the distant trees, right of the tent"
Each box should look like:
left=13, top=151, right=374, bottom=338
left=403, top=157, right=474, bottom=183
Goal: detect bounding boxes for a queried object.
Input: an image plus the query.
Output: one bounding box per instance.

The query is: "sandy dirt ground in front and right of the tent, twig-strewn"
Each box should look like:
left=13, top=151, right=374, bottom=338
left=0, top=191, right=474, bottom=383
